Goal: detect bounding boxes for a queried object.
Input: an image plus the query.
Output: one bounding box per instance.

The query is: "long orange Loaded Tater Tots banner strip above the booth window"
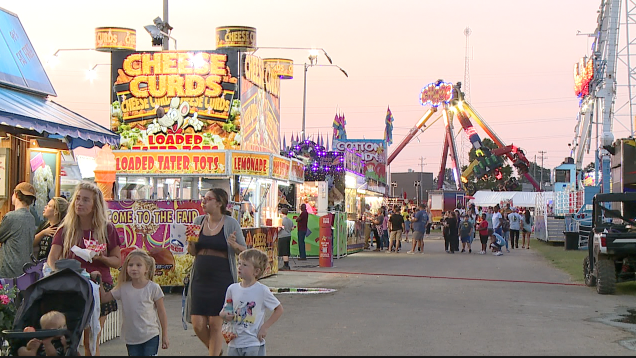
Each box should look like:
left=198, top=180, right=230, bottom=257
left=113, top=151, right=226, bottom=175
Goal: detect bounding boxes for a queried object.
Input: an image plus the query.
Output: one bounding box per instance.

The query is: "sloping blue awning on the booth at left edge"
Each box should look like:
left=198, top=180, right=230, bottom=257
left=0, top=88, right=119, bottom=149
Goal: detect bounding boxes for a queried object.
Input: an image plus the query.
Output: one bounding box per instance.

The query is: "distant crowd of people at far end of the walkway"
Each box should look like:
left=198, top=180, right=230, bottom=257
left=363, top=204, right=534, bottom=256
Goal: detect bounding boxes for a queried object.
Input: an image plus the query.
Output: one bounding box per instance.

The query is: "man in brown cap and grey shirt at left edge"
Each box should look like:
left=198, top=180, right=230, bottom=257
left=0, top=182, right=35, bottom=278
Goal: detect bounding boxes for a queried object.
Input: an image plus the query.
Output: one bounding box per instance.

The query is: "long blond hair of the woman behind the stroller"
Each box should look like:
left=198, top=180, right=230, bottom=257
left=62, top=181, right=108, bottom=258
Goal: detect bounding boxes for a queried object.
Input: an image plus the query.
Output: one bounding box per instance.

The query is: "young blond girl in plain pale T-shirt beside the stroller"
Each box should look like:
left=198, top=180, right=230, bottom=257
left=100, top=250, right=170, bottom=356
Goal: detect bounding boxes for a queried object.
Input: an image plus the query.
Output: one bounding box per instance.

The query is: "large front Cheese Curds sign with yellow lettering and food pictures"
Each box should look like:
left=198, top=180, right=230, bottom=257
left=111, top=49, right=241, bottom=150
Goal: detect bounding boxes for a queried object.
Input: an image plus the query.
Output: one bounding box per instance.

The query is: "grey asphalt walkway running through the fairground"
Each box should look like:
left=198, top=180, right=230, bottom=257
left=95, top=235, right=636, bottom=356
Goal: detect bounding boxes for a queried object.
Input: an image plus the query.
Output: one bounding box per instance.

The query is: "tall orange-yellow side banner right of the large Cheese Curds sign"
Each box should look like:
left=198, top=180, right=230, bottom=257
left=241, top=55, right=280, bottom=154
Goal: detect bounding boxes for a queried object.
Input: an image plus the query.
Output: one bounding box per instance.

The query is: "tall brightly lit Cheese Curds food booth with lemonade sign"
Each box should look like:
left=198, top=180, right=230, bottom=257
left=104, top=27, right=304, bottom=286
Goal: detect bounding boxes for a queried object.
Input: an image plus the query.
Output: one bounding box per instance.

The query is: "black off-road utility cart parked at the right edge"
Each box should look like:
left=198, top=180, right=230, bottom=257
left=583, top=193, right=636, bottom=294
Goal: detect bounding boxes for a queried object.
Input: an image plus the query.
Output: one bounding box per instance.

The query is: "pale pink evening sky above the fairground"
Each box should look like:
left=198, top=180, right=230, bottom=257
left=0, top=0, right=630, bottom=179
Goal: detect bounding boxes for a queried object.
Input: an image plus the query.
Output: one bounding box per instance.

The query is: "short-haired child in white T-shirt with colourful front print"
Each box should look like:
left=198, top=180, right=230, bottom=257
left=219, top=249, right=283, bottom=356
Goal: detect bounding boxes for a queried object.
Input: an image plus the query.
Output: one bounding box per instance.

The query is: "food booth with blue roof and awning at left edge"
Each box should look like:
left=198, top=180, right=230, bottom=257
left=0, top=9, right=118, bottom=224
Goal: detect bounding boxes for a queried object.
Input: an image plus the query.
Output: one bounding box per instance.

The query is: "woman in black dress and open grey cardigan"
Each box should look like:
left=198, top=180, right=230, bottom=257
left=188, top=188, right=246, bottom=356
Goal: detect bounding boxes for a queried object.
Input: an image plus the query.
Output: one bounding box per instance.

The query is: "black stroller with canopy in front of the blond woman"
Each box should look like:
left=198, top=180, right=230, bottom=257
left=2, top=260, right=95, bottom=355
